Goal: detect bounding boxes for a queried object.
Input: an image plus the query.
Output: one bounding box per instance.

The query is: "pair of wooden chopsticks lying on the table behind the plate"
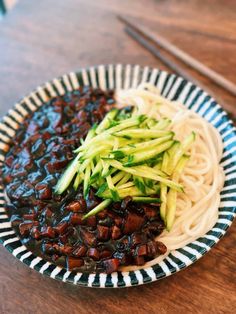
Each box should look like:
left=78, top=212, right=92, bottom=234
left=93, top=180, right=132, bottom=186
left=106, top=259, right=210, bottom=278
left=118, top=16, right=236, bottom=96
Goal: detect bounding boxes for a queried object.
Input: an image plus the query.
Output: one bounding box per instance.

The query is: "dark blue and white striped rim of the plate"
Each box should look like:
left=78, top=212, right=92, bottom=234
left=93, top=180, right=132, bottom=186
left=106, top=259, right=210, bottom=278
left=0, top=64, right=236, bottom=288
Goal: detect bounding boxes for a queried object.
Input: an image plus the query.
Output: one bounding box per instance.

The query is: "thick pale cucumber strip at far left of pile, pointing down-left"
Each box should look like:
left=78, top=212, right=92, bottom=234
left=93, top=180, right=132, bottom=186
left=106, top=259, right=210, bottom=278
left=55, top=155, right=80, bottom=194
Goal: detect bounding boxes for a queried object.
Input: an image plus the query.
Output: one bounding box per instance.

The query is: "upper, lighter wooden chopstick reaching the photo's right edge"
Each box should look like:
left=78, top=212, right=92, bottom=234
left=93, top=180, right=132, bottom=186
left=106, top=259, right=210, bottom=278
left=118, top=16, right=236, bottom=96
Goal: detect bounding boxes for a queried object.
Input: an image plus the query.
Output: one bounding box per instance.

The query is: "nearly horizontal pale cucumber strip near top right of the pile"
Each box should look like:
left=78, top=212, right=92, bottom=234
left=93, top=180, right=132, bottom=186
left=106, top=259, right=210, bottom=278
left=112, top=129, right=170, bottom=139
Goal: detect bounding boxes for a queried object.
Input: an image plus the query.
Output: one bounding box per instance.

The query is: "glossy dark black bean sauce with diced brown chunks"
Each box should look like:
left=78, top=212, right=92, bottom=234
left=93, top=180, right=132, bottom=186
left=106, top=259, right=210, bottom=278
left=1, top=87, right=166, bottom=273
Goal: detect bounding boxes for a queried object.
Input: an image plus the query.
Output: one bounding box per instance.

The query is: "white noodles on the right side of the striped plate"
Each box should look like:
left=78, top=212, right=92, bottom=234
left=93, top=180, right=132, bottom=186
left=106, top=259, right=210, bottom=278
left=117, top=83, right=224, bottom=271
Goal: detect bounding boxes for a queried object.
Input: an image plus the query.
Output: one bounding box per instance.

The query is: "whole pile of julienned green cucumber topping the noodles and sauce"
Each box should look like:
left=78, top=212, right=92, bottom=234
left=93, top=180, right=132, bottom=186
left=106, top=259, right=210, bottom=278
left=55, top=109, right=195, bottom=230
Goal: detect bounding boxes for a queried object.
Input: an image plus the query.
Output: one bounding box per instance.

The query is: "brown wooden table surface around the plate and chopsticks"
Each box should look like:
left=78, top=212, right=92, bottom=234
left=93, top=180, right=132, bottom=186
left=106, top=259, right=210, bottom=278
left=0, top=0, right=236, bottom=314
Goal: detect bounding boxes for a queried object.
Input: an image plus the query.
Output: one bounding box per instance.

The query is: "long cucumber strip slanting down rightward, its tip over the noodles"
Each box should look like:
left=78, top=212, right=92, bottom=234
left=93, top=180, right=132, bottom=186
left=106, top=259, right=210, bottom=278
left=109, top=160, right=183, bottom=192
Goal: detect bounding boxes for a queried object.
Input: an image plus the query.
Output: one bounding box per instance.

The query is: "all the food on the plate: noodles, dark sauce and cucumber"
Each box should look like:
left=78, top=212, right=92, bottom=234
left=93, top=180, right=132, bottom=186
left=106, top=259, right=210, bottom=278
left=1, top=83, right=224, bottom=273
